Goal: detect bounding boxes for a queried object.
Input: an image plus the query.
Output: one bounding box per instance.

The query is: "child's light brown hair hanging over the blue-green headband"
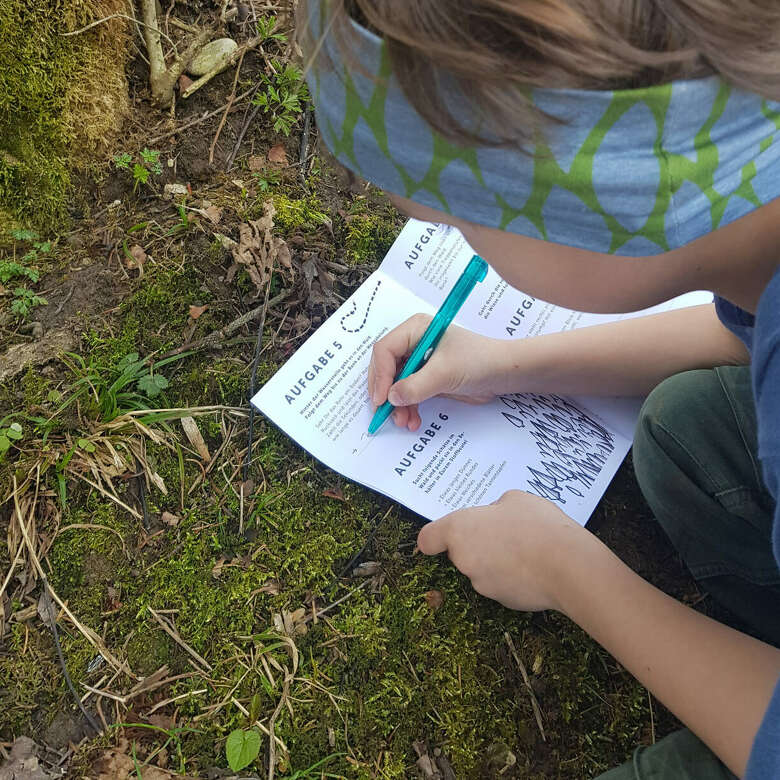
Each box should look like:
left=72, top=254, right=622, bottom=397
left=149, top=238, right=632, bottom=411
left=303, top=0, right=780, bottom=144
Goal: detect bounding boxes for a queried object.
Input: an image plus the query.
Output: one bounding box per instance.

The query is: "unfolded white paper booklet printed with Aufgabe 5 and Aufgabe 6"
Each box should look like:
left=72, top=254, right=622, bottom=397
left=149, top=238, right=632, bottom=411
left=252, top=220, right=712, bottom=524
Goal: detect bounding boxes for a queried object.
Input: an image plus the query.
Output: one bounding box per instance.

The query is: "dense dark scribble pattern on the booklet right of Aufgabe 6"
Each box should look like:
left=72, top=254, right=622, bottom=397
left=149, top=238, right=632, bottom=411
left=500, top=393, right=615, bottom=504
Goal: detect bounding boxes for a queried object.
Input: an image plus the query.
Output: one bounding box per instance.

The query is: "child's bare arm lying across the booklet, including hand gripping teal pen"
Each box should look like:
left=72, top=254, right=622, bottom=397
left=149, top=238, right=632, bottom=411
left=368, top=304, right=749, bottom=430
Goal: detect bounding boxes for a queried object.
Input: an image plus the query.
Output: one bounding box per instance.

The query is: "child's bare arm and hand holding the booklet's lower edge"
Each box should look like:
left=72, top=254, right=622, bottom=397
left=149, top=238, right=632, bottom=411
left=418, top=491, right=780, bottom=776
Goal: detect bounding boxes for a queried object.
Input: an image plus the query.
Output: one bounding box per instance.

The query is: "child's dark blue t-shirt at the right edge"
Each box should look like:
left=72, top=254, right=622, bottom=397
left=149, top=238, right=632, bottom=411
left=715, top=268, right=780, bottom=780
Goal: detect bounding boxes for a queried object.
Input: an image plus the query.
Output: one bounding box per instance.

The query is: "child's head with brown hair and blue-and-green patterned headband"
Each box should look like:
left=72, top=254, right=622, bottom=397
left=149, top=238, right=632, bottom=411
left=302, top=0, right=780, bottom=308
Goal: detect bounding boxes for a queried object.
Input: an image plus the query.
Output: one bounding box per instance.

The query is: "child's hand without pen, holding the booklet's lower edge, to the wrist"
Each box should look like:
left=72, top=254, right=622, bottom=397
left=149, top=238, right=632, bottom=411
left=417, top=490, right=605, bottom=611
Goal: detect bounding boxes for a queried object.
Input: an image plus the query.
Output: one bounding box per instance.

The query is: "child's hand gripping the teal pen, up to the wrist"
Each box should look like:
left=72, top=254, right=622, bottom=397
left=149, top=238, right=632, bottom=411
left=368, top=314, right=506, bottom=431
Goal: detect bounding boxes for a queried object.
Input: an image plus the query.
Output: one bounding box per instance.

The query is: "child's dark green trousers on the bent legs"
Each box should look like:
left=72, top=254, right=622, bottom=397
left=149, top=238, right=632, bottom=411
left=600, top=366, right=780, bottom=780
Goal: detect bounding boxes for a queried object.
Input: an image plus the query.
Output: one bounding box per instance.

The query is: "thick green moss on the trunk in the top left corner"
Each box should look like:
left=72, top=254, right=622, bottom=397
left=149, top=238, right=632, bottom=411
left=0, top=0, right=127, bottom=233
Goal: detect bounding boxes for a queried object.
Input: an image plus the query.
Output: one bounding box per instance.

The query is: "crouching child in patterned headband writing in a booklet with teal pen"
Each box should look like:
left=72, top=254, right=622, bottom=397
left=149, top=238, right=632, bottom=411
left=303, top=0, right=780, bottom=780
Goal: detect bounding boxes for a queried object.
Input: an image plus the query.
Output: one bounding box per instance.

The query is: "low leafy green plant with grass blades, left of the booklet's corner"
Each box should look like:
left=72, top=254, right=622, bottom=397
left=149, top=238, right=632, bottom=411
left=60, top=352, right=190, bottom=422
